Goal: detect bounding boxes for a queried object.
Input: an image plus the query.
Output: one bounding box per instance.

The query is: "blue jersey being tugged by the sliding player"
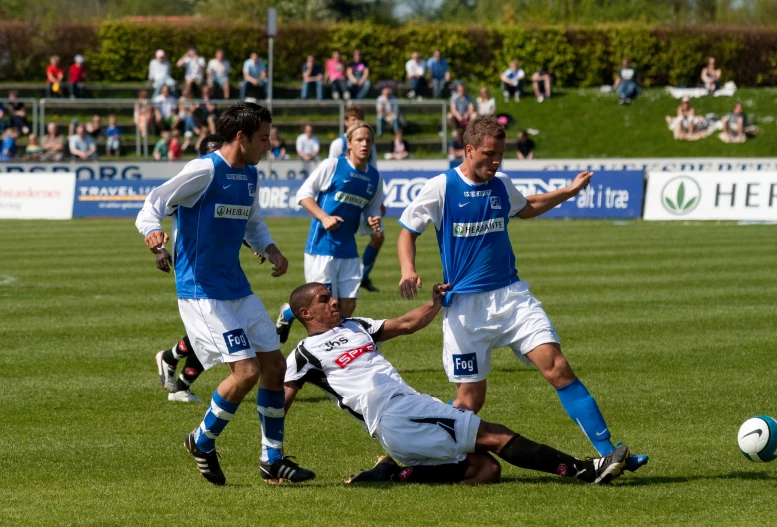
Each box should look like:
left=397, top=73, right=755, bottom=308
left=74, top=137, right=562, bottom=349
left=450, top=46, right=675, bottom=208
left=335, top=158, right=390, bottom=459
left=400, top=168, right=526, bottom=306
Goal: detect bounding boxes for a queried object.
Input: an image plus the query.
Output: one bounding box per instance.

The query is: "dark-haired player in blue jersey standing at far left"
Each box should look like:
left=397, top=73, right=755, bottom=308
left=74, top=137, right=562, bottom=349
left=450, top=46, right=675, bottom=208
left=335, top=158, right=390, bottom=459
left=136, top=103, right=315, bottom=485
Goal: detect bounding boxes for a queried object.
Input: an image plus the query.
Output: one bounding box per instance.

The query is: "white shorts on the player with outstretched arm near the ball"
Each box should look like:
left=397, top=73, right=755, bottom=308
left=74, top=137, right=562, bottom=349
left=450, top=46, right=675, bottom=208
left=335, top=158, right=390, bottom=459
left=442, top=281, right=560, bottom=383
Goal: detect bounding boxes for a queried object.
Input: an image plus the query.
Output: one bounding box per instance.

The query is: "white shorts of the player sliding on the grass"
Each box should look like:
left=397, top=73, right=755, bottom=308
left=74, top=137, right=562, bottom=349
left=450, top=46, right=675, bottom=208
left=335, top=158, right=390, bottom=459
left=373, top=393, right=480, bottom=465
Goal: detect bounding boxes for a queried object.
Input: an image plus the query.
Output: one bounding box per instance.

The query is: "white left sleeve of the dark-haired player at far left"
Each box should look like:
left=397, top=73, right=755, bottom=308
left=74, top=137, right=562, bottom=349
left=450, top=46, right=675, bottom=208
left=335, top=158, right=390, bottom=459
left=135, top=158, right=215, bottom=236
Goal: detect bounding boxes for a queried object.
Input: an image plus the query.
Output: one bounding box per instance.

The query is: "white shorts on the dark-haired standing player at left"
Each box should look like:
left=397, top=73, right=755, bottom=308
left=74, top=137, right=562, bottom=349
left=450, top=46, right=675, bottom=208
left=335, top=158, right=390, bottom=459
left=178, top=295, right=280, bottom=370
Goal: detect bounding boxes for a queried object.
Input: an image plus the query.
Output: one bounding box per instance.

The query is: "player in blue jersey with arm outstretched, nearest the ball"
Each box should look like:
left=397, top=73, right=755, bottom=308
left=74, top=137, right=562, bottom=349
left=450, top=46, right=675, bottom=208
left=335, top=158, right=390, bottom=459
left=397, top=117, right=648, bottom=470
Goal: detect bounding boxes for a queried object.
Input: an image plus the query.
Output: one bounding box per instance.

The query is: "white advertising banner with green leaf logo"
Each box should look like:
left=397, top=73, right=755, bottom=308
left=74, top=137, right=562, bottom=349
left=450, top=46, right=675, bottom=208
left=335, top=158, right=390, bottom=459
left=644, top=171, right=777, bottom=221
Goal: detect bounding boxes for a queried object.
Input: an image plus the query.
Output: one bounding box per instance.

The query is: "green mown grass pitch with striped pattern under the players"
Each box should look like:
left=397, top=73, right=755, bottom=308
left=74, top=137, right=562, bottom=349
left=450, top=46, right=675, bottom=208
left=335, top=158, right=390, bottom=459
left=0, top=217, right=777, bottom=526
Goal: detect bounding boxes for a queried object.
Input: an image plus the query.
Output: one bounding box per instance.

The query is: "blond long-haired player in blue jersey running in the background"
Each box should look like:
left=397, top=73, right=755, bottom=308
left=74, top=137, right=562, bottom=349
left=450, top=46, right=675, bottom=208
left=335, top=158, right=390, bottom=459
left=275, top=121, right=383, bottom=342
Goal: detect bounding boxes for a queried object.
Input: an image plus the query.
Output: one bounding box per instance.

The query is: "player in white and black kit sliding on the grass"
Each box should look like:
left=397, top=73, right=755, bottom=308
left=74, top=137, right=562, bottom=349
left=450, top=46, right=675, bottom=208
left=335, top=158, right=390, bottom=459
left=285, top=282, right=629, bottom=484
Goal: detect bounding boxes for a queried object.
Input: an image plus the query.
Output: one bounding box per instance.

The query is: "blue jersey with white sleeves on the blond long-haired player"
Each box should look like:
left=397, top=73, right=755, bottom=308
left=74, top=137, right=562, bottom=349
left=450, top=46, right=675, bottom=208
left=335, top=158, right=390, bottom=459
left=297, top=156, right=383, bottom=258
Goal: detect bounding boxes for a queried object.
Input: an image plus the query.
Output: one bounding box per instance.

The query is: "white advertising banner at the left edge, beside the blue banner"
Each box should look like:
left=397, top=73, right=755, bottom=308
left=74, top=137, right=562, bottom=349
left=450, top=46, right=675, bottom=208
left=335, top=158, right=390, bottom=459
left=0, top=172, right=76, bottom=220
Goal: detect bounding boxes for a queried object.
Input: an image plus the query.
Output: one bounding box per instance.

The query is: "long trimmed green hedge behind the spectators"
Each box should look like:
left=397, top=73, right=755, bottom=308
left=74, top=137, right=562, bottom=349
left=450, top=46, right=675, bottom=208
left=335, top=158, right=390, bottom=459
left=0, top=20, right=777, bottom=87
